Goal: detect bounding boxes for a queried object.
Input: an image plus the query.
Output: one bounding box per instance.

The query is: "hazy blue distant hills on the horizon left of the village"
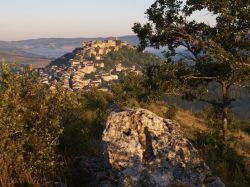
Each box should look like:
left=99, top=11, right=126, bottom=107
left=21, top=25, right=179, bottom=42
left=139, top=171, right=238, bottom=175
left=0, top=36, right=139, bottom=67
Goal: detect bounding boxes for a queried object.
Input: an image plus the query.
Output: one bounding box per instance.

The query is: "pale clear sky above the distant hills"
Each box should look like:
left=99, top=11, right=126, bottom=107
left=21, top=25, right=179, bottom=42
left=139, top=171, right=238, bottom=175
left=0, top=0, right=215, bottom=41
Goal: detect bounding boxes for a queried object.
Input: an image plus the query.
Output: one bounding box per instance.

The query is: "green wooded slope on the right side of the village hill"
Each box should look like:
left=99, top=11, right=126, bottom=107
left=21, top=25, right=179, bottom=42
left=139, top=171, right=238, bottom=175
left=104, top=47, right=161, bottom=69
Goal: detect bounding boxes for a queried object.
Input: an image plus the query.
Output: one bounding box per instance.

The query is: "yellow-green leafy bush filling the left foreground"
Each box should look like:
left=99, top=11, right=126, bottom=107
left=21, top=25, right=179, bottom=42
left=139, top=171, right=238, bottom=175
left=0, top=64, right=66, bottom=182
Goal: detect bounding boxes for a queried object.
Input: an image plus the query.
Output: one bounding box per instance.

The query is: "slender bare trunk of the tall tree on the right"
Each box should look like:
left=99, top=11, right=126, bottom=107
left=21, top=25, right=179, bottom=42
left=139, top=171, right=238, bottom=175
left=222, top=82, right=230, bottom=140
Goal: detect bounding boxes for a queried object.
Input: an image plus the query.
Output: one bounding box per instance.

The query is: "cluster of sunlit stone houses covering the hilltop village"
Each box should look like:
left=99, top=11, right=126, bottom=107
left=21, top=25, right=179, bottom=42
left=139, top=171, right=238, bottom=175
left=39, top=40, right=141, bottom=91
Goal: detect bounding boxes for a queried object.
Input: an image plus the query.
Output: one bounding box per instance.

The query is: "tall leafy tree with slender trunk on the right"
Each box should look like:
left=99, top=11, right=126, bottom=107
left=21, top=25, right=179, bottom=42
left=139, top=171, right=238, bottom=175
left=133, top=0, right=250, bottom=138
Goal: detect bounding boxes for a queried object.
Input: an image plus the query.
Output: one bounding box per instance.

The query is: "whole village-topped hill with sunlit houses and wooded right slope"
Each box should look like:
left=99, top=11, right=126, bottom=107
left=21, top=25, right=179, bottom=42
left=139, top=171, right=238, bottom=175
left=40, top=39, right=161, bottom=91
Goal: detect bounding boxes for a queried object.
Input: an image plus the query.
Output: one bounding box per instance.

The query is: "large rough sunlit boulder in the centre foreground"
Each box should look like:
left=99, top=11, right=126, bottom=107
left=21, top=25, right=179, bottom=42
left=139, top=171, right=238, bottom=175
left=103, top=109, right=224, bottom=187
